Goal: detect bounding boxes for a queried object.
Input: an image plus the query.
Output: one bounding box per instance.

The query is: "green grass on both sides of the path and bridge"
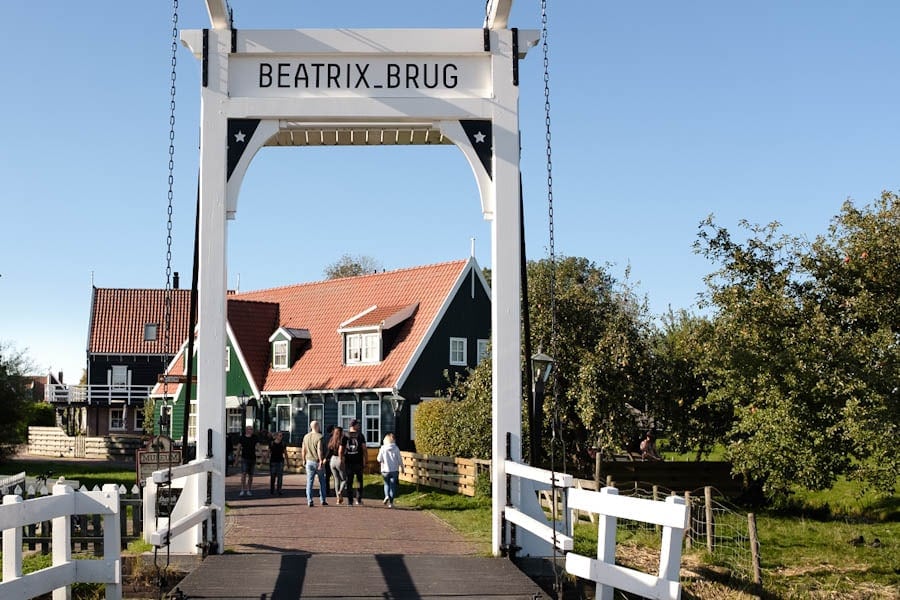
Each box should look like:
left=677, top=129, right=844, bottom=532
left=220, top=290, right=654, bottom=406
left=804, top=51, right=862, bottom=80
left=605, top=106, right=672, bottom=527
left=0, top=461, right=900, bottom=600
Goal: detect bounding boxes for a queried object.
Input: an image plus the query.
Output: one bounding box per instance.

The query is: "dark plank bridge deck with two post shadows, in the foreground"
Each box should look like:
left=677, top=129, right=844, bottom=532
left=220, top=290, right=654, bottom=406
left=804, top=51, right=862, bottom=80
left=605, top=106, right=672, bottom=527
left=172, top=554, right=548, bottom=600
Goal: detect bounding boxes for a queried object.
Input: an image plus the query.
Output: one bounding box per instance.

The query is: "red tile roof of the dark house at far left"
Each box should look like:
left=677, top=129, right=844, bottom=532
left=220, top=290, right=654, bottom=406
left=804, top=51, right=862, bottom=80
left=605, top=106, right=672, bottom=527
left=88, top=288, right=190, bottom=354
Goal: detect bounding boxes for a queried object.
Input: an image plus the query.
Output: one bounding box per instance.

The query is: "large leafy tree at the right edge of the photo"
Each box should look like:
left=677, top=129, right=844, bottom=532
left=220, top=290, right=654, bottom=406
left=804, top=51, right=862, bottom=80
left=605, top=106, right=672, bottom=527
left=697, top=193, right=900, bottom=496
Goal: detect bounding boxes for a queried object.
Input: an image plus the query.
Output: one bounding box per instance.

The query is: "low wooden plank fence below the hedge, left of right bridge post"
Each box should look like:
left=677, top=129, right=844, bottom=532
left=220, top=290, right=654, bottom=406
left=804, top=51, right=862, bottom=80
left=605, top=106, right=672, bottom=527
left=400, top=452, right=490, bottom=496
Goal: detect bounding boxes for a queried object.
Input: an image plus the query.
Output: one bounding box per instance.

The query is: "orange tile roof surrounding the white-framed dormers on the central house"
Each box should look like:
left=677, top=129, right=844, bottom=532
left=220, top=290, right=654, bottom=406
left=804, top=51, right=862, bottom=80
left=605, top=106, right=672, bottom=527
left=239, top=260, right=474, bottom=392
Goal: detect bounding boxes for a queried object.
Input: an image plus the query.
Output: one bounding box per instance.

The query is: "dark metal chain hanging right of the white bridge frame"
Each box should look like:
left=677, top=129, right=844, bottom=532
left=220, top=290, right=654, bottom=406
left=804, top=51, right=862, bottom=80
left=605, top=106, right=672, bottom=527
left=541, top=0, right=565, bottom=598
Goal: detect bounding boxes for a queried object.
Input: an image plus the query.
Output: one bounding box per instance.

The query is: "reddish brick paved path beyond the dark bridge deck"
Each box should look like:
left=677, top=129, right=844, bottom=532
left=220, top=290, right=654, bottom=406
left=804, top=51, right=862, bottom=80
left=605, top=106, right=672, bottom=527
left=225, top=473, right=489, bottom=555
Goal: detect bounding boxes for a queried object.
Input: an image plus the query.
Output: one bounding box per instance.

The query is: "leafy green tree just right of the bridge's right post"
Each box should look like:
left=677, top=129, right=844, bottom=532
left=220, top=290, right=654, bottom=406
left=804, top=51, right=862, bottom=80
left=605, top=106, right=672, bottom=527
left=525, top=257, right=651, bottom=472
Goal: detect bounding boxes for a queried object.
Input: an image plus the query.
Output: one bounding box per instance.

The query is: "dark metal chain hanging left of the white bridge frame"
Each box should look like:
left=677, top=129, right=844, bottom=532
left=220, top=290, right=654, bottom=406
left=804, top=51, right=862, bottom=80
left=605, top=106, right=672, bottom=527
left=153, top=0, right=178, bottom=599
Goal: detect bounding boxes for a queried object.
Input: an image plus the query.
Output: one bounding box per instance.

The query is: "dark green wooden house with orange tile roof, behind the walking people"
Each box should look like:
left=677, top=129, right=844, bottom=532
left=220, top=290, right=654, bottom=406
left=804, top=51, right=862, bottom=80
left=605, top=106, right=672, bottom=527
left=153, top=258, right=491, bottom=449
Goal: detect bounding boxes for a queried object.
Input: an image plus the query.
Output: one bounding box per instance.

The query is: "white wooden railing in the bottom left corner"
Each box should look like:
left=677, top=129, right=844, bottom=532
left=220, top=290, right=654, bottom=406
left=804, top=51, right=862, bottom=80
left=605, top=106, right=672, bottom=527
left=0, top=483, right=122, bottom=600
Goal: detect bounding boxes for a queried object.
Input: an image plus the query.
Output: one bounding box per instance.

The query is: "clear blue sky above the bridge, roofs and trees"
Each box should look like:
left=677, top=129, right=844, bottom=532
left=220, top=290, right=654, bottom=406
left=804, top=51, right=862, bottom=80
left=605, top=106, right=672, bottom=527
left=0, top=0, right=900, bottom=381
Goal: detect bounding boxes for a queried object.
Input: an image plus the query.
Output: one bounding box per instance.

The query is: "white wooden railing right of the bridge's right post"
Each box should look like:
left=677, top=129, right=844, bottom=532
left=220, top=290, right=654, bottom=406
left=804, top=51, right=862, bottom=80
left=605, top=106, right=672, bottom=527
left=505, top=461, right=690, bottom=600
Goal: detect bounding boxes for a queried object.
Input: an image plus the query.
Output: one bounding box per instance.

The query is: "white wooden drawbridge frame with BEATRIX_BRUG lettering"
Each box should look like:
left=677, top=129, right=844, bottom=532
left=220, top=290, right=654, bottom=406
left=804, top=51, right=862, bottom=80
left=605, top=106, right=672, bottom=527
left=170, top=0, right=546, bottom=555
